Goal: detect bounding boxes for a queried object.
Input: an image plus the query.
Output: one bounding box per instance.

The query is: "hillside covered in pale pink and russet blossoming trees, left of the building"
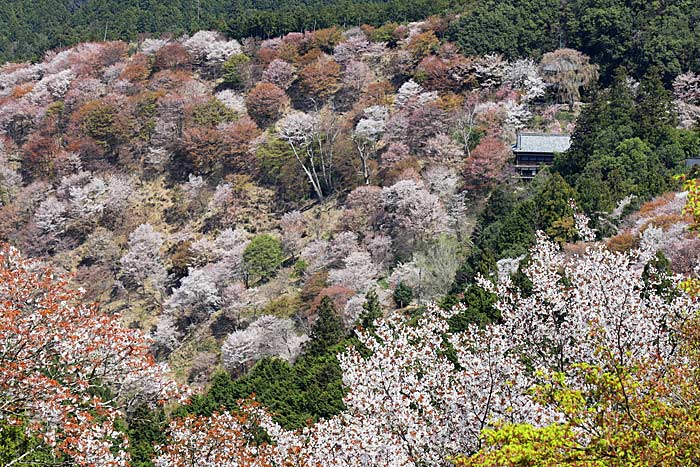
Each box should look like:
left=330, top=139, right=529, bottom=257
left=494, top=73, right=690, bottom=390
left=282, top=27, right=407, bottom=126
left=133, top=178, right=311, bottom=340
left=0, top=21, right=595, bottom=384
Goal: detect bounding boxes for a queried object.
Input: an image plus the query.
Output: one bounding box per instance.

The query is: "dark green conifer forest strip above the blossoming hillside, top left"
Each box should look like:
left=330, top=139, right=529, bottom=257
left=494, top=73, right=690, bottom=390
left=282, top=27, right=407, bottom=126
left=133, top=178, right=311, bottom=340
left=0, top=0, right=457, bottom=61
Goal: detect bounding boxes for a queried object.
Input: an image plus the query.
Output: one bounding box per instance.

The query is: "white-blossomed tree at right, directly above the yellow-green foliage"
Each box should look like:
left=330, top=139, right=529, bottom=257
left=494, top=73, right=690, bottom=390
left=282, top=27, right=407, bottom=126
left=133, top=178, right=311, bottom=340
left=497, top=232, right=697, bottom=378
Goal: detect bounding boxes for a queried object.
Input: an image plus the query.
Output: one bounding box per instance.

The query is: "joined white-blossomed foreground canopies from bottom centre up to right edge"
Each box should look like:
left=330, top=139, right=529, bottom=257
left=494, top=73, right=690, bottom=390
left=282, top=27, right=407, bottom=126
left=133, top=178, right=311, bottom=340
left=150, top=216, right=698, bottom=467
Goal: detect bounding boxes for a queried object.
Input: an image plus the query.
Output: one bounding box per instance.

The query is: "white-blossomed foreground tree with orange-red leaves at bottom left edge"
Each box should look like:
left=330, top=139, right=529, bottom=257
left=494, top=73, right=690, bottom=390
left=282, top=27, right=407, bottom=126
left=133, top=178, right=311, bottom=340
left=0, top=245, right=180, bottom=466
